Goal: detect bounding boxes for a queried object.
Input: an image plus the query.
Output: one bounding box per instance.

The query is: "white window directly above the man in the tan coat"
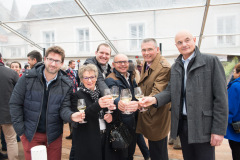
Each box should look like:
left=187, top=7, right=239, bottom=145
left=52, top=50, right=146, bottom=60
left=130, top=24, right=145, bottom=50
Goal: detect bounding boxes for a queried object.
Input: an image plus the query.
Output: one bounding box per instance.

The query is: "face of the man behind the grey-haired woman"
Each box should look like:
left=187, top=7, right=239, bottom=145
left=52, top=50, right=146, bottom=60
left=95, top=45, right=111, bottom=65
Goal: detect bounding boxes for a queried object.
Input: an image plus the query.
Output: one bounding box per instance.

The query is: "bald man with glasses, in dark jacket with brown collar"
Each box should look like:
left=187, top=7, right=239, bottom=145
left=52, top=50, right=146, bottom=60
left=105, top=54, right=138, bottom=160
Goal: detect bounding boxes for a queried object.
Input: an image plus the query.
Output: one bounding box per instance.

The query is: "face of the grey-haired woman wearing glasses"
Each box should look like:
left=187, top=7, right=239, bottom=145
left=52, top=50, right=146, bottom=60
left=81, top=71, right=97, bottom=90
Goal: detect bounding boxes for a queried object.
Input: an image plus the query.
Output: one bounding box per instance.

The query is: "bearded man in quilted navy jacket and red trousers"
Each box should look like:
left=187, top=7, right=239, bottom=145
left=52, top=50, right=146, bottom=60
left=10, top=46, right=82, bottom=160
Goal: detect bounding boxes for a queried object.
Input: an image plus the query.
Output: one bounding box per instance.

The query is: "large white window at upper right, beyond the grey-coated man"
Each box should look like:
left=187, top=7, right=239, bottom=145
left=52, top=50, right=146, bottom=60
left=217, top=16, right=236, bottom=46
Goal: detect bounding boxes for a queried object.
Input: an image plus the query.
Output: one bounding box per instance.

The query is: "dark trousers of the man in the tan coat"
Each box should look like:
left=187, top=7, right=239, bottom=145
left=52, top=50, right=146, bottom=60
left=148, top=137, right=168, bottom=160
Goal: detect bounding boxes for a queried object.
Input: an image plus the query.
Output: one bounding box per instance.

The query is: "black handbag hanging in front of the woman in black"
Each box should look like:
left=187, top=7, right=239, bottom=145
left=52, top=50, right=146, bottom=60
left=109, top=121, right=132, bottom=150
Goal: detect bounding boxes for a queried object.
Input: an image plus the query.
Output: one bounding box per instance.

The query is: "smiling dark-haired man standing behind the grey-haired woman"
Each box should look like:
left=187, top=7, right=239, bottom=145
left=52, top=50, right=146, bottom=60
left=84, top=43, right=111, bottom=95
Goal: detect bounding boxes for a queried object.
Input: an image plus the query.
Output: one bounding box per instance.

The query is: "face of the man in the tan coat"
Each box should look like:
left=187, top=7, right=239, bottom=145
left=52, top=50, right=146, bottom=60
left=141, top=41, right=159, bottom=63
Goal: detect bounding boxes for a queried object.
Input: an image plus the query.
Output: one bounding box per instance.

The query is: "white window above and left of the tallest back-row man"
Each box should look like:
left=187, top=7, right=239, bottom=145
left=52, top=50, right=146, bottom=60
left=77, top=28, right=90, bottom=52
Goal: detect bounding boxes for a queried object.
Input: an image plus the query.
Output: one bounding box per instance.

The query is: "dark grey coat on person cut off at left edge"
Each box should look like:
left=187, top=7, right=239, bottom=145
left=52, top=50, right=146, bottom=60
left=0, top=63, right=19, bottom=124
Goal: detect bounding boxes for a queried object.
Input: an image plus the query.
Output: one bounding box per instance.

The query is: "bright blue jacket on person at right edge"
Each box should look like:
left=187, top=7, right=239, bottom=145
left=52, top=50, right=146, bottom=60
left=225, top=78, right=240, bottom=142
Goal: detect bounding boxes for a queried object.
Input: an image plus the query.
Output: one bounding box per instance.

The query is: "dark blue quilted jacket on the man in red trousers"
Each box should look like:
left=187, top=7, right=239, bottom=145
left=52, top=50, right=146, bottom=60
left=9, top=64, right=73, bottom=144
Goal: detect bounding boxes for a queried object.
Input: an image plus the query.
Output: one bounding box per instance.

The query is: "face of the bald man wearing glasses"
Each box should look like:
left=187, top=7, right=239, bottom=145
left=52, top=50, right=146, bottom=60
left=112, top=54, right=129, bottom=75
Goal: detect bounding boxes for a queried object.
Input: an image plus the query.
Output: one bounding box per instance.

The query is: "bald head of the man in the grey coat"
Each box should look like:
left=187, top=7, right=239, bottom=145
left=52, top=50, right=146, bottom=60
left=175, top=30, right=196, bottom=59
